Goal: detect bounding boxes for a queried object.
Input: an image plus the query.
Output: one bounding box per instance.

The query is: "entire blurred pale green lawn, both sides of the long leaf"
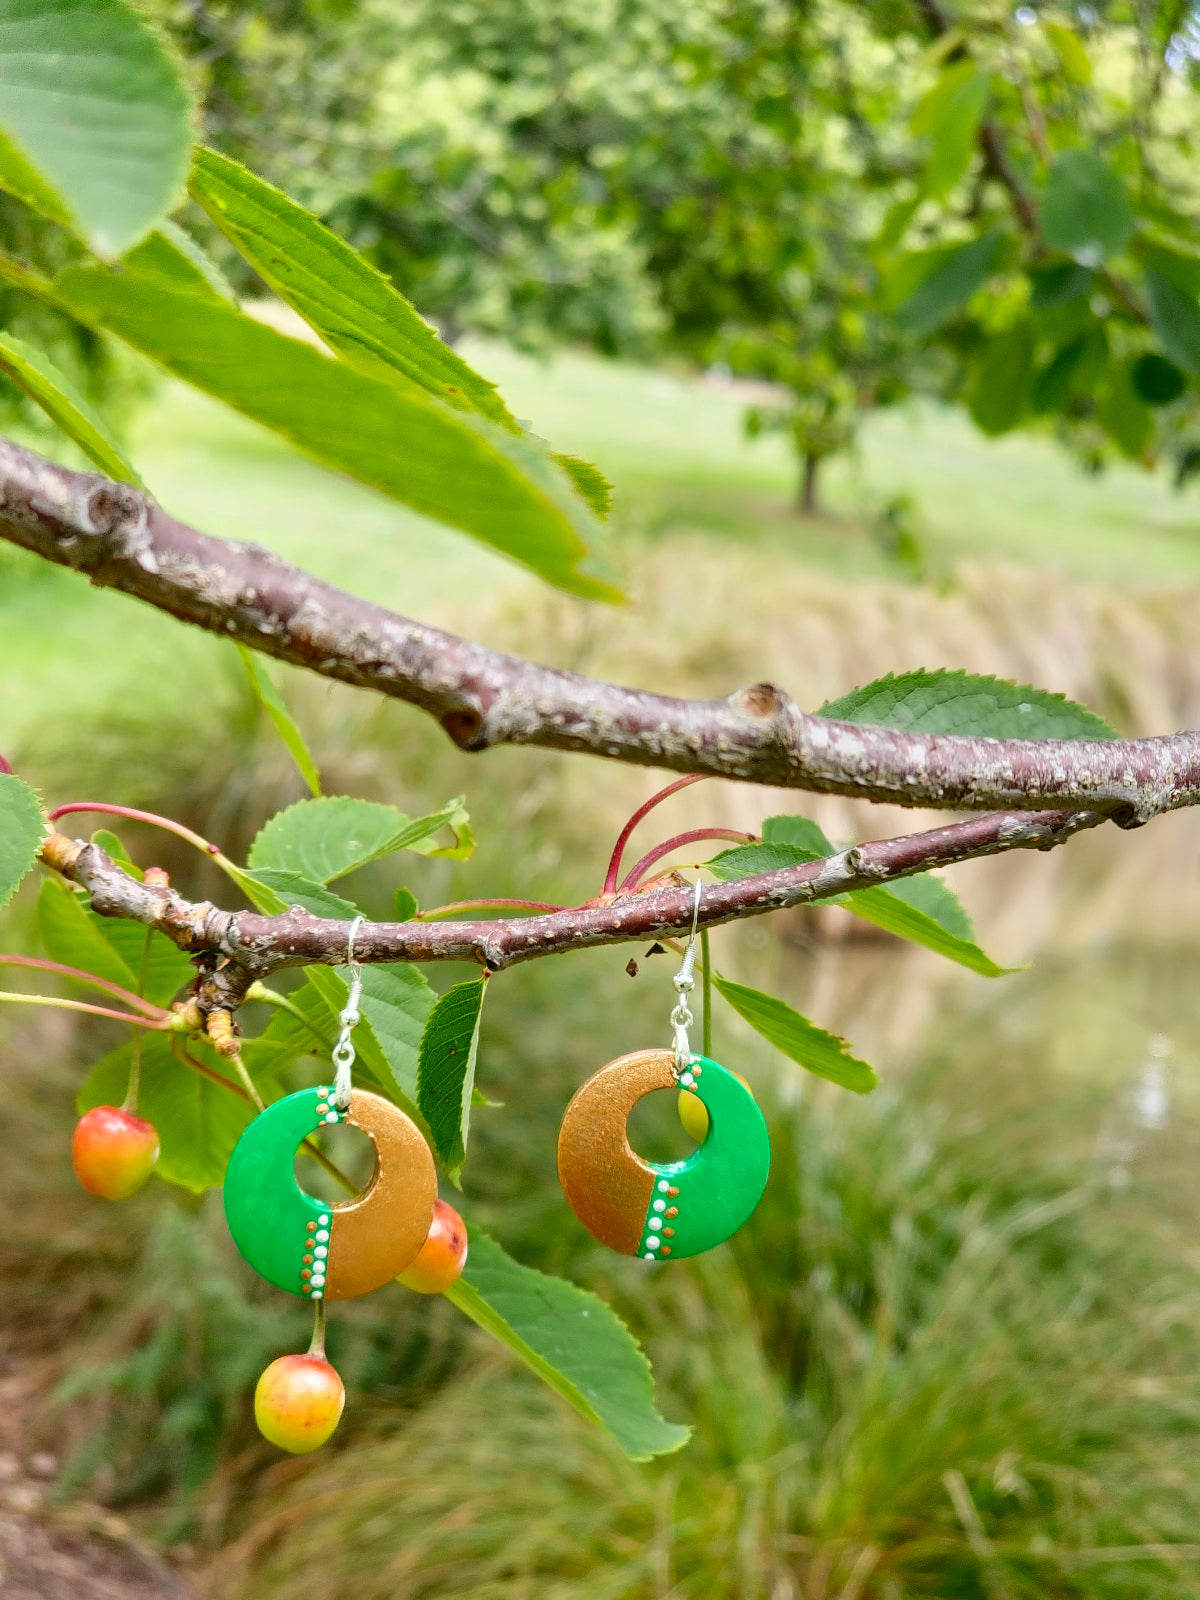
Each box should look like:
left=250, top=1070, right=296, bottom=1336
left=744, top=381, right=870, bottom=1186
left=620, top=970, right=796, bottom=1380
left=0, top=346, right=1200, bottom=781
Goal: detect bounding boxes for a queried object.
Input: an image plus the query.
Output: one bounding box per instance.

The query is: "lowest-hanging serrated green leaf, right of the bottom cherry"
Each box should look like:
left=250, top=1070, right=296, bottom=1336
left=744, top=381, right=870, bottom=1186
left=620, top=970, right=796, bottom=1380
left=446, top=1227, right=691, bottom=1461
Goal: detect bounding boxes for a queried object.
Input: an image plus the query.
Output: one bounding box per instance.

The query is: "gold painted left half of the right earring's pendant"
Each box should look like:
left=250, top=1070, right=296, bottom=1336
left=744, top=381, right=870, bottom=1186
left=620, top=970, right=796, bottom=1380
left=558, top=1050, right=675, bottom=1256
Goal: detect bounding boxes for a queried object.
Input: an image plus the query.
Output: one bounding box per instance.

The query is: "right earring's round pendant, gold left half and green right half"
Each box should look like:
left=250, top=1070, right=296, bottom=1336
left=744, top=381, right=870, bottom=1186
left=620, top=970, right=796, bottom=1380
left=558, top=1050, right=771, bottom=1261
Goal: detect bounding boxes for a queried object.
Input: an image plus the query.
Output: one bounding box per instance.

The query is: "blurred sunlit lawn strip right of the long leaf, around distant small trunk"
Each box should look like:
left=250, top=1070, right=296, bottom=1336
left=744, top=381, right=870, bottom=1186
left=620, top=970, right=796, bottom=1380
left=470, top=346, right=1200, bottom=584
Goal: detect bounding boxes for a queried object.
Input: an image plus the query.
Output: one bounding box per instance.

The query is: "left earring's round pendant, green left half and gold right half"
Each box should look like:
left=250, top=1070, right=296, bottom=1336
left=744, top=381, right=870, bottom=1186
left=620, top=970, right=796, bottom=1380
left=226, top=1086, right=437, bottom=1299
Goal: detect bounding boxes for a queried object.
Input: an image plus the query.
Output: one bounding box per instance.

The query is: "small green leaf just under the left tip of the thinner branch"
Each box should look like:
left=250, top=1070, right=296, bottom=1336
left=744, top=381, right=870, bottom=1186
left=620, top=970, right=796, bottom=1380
left=37, top=878, right=194, bottom=1005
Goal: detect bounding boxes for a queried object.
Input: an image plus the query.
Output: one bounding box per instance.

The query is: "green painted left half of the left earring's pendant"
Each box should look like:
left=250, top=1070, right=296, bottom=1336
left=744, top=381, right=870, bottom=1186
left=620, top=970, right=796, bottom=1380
left=226, top=1088, right=331, bottom=1294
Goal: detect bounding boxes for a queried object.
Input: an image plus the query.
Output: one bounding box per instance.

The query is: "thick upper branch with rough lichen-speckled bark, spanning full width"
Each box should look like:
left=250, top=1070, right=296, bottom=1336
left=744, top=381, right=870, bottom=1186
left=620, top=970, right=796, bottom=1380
left=0, top=440, right=1200, bottom=824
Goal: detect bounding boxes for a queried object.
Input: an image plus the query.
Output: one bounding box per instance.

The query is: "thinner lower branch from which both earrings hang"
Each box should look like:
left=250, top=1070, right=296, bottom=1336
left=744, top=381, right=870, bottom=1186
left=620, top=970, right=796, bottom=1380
left=42, top=811, right=1106, bottom=979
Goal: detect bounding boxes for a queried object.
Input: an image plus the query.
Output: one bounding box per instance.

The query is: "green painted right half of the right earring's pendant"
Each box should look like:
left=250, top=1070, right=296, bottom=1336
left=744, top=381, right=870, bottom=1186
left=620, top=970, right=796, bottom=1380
left=638, top=1056, right=771, bottom=1261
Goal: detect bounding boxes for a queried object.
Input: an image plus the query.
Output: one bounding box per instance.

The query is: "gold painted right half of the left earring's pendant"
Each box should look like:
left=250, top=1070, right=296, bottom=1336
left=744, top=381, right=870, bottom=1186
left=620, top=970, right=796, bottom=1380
left=325, top=1090, right=437, bottom=1299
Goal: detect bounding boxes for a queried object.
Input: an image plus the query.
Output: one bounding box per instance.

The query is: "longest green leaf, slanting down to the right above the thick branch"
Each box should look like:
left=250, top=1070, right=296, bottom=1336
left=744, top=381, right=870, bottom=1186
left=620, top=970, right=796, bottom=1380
left=54, top=267, right=621, bottom=600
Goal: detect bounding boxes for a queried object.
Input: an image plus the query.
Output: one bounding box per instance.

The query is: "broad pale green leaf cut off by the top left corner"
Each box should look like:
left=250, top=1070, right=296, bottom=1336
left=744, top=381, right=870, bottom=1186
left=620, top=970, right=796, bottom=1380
left=0, top=0, right=192, bottom=256
